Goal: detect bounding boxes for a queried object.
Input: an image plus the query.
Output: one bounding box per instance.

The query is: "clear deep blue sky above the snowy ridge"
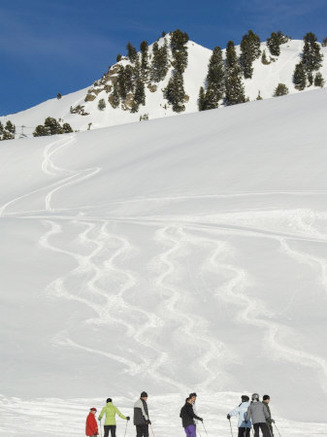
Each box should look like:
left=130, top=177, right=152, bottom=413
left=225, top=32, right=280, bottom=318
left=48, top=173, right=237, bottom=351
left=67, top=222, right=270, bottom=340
left=0, top=0, right=327, bottom=115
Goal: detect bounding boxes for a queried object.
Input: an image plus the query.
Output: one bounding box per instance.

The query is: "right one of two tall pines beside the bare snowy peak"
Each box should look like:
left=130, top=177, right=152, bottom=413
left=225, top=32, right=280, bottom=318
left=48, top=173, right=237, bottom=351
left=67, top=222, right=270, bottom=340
left=225, top=41, right=246, bottom=106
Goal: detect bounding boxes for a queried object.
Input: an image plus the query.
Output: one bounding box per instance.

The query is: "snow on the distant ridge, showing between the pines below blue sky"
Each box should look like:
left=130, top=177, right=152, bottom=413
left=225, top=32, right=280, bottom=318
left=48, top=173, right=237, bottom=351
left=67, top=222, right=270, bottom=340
left=0, top=35, right=327, bottom=136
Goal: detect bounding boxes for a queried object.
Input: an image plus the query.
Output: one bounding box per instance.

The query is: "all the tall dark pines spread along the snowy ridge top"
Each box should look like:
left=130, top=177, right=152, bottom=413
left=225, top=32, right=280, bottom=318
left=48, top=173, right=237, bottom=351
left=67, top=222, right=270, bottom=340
left=88, top=29, right=327, bottom=118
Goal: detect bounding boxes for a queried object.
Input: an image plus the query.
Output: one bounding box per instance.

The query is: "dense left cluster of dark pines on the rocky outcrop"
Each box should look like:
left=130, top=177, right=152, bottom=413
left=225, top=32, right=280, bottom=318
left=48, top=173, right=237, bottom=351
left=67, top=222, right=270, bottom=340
left=85, top=29, right=189, bottom=112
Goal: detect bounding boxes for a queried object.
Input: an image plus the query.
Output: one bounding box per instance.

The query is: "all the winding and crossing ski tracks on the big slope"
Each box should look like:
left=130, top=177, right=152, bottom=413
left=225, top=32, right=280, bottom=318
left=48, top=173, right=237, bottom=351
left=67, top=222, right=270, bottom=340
left=0, top=136, right=327, bottom=436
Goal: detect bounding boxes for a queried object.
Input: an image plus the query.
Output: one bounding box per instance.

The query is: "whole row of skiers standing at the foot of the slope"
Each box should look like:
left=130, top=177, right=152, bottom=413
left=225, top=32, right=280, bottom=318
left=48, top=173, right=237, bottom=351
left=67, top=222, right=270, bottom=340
left=85, top=391, right=275, bottom=437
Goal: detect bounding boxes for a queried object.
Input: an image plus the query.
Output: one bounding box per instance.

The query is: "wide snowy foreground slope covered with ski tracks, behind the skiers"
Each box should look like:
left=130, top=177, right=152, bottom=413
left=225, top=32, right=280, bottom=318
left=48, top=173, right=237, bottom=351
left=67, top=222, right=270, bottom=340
left=0, top=90, right=327, bottom=437
